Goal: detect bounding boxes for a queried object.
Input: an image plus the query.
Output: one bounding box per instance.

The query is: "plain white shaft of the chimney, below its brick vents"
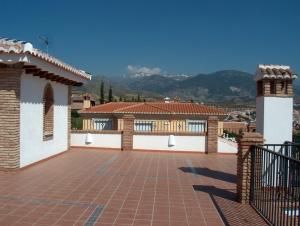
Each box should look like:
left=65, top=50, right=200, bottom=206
left=256, top=97, right=293, bottom=144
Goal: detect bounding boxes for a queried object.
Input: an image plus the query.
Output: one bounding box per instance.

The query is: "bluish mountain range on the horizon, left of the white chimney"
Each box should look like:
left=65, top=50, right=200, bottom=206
left=124, top=70, right=255, bottom=102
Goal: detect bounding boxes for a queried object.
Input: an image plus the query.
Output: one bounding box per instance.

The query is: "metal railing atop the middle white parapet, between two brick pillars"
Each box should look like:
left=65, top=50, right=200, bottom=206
left=134, top=120, right=207, bottom=133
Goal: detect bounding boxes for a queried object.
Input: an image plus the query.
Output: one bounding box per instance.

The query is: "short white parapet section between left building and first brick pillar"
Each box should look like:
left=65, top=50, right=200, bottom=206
left=71, top=133, right=122, bottom=149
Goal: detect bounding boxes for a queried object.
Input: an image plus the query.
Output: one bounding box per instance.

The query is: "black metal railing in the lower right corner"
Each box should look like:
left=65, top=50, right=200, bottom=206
left=250, top=143, right=300, bottom=226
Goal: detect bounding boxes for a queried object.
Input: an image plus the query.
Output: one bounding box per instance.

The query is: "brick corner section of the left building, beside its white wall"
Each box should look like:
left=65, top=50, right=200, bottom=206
left=0, top=65, right=22, bottom=170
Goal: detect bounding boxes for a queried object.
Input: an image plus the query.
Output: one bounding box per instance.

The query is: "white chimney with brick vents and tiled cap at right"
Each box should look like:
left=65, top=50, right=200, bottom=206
left=255, top=64, right=297, bottom=144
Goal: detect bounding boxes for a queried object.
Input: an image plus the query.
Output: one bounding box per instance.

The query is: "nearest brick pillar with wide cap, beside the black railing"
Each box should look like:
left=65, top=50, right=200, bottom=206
left=237, top=133, right=264, bottom=204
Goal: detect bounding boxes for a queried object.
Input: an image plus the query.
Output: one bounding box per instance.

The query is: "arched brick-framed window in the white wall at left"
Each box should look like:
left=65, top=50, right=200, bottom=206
left=43, top=83, right=54, bottom=140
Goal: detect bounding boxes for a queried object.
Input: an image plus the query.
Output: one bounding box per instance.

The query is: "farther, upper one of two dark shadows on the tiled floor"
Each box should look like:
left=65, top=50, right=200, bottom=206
left=179, top=167, right=236, bottom=183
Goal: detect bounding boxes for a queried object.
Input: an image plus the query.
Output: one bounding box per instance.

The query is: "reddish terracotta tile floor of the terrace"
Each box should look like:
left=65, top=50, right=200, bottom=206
left=0, top=149, right=264, bottom=226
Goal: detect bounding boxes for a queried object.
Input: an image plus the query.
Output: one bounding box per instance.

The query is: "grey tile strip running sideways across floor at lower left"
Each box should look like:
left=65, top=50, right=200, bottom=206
left=0, top=196, right=97, bottom=207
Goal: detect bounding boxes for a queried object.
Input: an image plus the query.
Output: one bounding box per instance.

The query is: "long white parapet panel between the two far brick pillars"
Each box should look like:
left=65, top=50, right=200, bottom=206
left=133, top=135, right=206, bottom=152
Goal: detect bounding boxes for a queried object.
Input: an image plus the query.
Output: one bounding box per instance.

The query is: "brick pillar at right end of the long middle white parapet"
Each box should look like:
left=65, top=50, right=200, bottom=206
left=206, top=116, right=218, bottom=154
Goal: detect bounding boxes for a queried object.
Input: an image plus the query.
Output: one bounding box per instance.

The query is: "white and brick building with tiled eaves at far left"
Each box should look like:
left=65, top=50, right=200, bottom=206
left=0, top=39, right=91, bottom=169
